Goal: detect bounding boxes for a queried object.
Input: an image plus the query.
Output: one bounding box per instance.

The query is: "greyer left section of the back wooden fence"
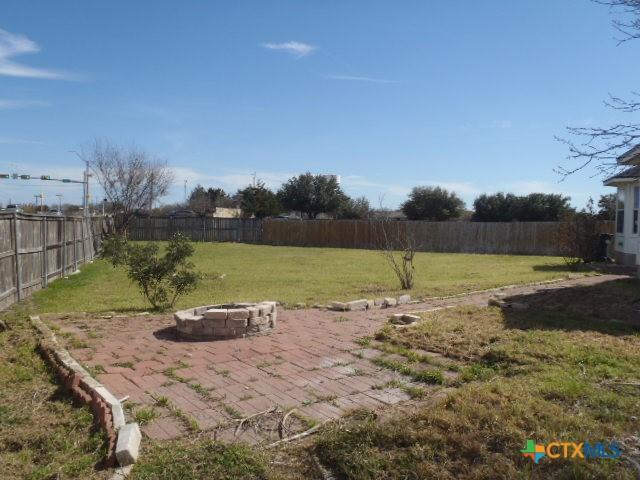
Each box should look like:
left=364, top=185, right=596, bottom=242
left=128, top=217, right=262, bottom=243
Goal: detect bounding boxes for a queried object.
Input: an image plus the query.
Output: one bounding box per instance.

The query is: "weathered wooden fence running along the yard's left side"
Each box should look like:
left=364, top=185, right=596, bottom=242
left=0, top=213, right=110, bottom=310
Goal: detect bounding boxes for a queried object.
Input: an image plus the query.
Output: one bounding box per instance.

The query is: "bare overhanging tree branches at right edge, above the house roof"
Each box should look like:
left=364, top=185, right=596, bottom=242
left=556, top=0, right=640, bottom=177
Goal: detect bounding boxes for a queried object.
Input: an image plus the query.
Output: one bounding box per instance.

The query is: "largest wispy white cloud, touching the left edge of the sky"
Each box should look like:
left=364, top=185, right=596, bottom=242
left=0, top=29, right=77, bottom=80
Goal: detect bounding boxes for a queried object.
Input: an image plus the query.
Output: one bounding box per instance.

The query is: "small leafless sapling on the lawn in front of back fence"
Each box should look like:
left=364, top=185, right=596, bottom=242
left=372, top=216, right=418, bottom=290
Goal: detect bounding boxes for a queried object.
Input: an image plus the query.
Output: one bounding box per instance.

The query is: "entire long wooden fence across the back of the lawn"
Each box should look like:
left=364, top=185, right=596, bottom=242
left=129, top=218, right=613, bottom=255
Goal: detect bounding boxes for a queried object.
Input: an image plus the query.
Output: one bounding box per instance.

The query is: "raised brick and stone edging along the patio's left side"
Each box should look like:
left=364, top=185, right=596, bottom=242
left=29, top=315, right=141, bottom=476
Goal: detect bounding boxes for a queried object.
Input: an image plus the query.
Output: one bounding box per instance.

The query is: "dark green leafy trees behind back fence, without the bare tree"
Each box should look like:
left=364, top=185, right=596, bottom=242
left=172, top=181, right=616, bottom=222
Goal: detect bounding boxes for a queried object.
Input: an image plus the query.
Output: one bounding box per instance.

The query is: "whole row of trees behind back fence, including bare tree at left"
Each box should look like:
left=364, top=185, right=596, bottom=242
left=82, top=140, right=616, bottom=231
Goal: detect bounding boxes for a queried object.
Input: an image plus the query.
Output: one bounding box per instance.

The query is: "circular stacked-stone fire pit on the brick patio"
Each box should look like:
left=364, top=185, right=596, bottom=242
left=174, top=302, right=277, bottom=340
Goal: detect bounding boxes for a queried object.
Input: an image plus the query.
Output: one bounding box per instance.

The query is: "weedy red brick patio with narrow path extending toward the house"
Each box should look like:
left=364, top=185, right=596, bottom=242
left=48, top=275, right=616, bottom=441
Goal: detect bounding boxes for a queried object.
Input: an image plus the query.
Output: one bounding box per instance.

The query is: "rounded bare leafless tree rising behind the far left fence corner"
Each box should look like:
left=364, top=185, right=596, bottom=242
left=81, top=140, right=173, bottom=233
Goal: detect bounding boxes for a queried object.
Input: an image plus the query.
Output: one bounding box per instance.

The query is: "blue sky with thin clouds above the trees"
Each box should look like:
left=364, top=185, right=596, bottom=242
left=0, top=0, right=640, bottom=207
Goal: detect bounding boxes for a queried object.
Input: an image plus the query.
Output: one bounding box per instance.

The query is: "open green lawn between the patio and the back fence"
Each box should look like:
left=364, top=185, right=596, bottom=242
left=35, top=243, right=584, bottom=312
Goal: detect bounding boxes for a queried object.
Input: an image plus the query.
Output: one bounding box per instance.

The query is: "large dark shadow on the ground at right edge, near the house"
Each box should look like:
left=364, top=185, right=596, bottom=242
left=503, top=279, right=640, bottom=336
